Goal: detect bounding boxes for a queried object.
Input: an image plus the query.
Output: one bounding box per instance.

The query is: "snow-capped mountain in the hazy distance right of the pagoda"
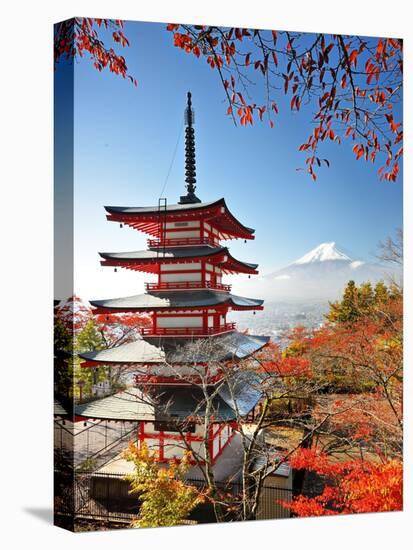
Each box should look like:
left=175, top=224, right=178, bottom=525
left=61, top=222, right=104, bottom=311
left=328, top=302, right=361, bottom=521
left=233, top=242, right=391, bottom=302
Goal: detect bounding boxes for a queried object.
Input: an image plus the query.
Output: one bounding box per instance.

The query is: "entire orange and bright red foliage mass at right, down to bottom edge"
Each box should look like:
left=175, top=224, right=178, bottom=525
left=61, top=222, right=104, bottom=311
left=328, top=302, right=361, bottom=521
left=280, top=281, right=403, bottom=516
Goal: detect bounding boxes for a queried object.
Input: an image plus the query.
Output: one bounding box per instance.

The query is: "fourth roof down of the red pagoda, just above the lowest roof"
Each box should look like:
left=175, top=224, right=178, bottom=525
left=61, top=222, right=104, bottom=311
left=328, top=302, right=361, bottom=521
left=79, top=331, right=270, bottom=367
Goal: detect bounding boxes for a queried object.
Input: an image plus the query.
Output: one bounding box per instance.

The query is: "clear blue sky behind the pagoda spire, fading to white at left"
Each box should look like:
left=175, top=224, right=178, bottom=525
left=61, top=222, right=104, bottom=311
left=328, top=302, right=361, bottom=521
left=53, top=22, right=402, bottom=297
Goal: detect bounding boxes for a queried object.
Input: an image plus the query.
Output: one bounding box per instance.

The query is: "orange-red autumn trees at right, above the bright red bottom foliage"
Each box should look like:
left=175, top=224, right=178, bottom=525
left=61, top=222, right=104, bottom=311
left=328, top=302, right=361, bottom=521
left=286, top=284, right=403, bottom=460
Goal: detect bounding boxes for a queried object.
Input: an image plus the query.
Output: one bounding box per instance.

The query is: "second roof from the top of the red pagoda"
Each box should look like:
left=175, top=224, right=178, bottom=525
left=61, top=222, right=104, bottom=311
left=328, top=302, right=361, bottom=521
left=99, top=246, right=258, bottom=273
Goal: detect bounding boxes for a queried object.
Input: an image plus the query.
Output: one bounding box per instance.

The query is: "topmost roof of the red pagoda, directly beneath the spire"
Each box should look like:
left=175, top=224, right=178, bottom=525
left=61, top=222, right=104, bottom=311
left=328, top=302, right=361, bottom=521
left=104, top=198, right=255, bottom=239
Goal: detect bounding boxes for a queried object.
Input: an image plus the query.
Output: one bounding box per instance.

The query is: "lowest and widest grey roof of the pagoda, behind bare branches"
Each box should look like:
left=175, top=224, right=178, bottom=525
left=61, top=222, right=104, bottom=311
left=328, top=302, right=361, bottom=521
left=75, top=371, right=261, bottom=422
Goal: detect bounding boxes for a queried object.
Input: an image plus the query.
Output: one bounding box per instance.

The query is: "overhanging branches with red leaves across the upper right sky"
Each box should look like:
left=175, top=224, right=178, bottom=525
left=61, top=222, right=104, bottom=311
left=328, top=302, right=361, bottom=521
left=167, top=23, right=403, bottom=181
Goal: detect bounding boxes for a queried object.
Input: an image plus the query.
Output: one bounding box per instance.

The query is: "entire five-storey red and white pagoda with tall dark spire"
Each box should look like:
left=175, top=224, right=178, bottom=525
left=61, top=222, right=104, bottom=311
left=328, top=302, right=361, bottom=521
left=76, top=92, right=269, bottom=462
